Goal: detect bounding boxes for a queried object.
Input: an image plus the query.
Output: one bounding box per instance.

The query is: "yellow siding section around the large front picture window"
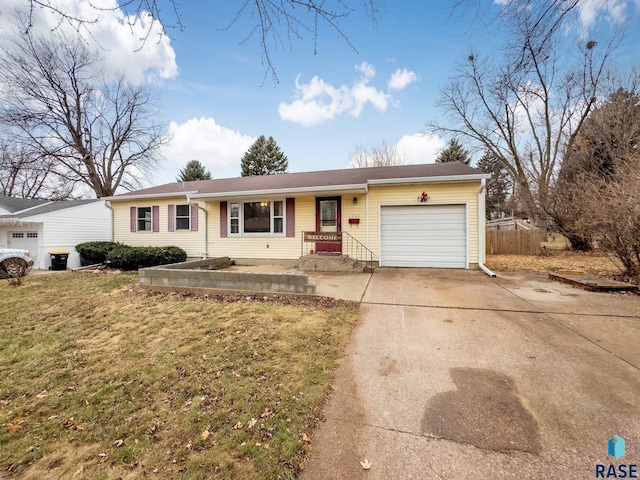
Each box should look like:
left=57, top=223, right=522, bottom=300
left=207, top=197, right=316, bottom=260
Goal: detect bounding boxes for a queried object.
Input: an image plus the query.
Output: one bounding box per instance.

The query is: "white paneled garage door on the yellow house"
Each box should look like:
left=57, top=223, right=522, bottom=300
left=380, top=205, right=467, bottom=268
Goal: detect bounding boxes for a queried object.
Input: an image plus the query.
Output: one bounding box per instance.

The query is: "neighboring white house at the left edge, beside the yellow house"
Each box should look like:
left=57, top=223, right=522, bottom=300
left=0, top=196, right=113, bottom=270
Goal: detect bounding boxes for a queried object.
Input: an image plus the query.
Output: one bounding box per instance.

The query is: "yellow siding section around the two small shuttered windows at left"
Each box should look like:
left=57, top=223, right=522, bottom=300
left=111, top=197, right=206, bottom=257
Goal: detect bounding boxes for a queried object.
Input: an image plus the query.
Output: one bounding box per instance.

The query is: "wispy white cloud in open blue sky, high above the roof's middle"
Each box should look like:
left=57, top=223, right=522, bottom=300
left=278, top=62, right=400, bottom=126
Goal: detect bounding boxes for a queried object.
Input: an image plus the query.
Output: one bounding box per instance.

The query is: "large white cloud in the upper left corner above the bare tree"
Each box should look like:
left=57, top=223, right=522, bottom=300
left=0, top=0, right=178, bottom=83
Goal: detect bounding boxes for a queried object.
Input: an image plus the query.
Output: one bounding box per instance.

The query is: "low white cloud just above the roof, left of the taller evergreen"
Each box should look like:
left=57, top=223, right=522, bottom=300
left=156, top=117, right=255, bottom=182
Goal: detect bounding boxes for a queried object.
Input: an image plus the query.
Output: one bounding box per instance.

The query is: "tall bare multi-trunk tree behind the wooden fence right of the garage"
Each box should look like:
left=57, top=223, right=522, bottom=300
left=428, top=6, right=619, bottom=226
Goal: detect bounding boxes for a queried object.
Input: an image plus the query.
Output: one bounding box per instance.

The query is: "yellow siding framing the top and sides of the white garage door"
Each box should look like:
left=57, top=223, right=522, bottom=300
left=368, top=181, right=480, bottom=263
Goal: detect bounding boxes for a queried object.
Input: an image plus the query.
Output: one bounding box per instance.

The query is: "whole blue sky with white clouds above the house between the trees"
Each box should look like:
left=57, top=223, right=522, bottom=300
left=0, top=0, right=633, bottom=188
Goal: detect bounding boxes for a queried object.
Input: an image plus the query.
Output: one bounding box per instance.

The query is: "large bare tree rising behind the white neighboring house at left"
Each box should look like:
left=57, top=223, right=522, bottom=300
left=0, top=25, right=169, bottom=197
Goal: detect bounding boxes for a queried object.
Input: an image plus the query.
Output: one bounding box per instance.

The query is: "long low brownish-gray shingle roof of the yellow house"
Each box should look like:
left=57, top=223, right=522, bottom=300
left=109, top=162, right=485, bottom=201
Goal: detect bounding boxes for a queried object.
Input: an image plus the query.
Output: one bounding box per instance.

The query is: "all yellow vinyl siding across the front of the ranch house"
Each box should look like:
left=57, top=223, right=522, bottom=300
left=112, top=181, right=484, bottom=264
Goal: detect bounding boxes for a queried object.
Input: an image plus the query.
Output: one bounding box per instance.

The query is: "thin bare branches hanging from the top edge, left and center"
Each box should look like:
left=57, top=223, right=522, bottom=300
left=24, top=0, right=378, bottom=82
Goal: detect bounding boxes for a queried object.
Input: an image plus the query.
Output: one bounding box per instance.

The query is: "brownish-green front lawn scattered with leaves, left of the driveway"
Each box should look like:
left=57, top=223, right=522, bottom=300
left=0, top=273, right=357, bottom=479
